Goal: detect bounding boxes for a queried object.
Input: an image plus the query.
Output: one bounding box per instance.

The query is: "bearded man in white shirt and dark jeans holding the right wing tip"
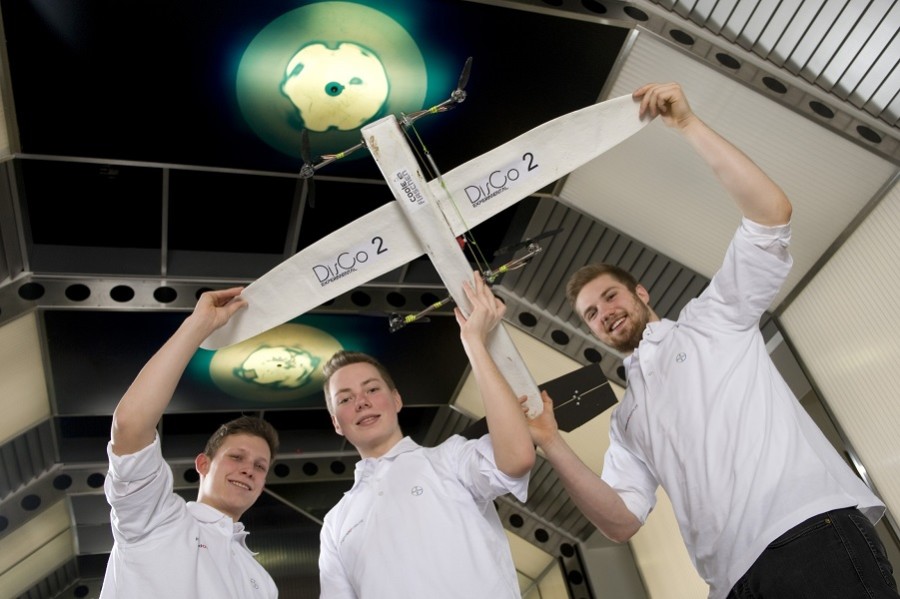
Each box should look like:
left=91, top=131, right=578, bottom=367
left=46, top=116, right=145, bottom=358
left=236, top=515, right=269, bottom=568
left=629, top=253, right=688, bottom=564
left=530, top=83, right=898, bottom=599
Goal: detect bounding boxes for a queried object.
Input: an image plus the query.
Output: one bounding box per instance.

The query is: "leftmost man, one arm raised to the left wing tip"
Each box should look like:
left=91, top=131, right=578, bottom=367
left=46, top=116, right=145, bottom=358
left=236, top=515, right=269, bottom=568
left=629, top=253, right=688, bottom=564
left=100, top=287, right=278, bottom=599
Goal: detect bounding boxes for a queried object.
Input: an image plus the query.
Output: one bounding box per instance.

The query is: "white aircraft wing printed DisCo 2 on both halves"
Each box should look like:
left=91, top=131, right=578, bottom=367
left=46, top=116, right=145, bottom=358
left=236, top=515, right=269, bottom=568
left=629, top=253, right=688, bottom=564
left=202, top=96, right=649, bottom=349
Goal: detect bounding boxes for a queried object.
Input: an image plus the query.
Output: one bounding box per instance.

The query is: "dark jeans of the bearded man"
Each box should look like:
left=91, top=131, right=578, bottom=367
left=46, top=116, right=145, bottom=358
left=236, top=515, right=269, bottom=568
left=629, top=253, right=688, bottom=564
left=728, top=508, right=900, bottom=599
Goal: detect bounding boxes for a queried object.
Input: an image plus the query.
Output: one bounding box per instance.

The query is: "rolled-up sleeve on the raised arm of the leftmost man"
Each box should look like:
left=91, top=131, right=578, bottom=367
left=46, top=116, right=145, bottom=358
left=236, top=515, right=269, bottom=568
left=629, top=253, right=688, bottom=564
left=103, top=435, right=186, bottom=543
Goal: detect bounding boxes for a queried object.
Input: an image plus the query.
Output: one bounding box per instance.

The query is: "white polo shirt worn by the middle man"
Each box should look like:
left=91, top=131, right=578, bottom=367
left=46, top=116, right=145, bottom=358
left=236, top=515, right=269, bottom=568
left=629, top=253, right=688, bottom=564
left=319, top=435, right=529, bottom=599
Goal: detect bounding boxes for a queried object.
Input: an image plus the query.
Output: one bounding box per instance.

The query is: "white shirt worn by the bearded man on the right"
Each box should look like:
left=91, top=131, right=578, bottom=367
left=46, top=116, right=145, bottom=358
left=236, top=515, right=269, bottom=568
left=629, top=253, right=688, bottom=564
left=602, top=219, right=884, bottom=599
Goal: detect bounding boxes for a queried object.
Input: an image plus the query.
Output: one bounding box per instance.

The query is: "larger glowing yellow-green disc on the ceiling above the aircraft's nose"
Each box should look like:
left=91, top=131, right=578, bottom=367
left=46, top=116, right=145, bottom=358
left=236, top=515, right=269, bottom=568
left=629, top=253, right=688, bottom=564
left=236, top=2, right=427, bottom=158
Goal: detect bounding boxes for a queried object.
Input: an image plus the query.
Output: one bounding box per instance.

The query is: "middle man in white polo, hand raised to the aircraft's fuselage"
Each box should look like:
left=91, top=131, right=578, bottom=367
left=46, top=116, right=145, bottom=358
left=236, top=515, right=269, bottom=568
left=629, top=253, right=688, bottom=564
left=319, top=273, right=535, bottom=599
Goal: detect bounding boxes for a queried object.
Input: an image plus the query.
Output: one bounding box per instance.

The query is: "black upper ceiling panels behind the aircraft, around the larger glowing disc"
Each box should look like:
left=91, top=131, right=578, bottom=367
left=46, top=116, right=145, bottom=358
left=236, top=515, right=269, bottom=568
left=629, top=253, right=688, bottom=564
left=3, top=1, right=626, bottom=278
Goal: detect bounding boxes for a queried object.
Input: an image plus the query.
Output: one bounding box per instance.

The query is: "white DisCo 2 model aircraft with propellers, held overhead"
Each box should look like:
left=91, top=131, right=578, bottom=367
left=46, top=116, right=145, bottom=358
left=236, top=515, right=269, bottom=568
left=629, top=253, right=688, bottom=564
left=202, top=63, right=650, bottom=417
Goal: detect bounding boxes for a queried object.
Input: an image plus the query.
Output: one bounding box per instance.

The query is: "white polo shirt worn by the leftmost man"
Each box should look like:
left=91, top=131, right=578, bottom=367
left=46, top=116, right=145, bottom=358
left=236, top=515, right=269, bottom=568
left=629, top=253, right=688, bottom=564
left=100, top=436, right=278, bottom=599
